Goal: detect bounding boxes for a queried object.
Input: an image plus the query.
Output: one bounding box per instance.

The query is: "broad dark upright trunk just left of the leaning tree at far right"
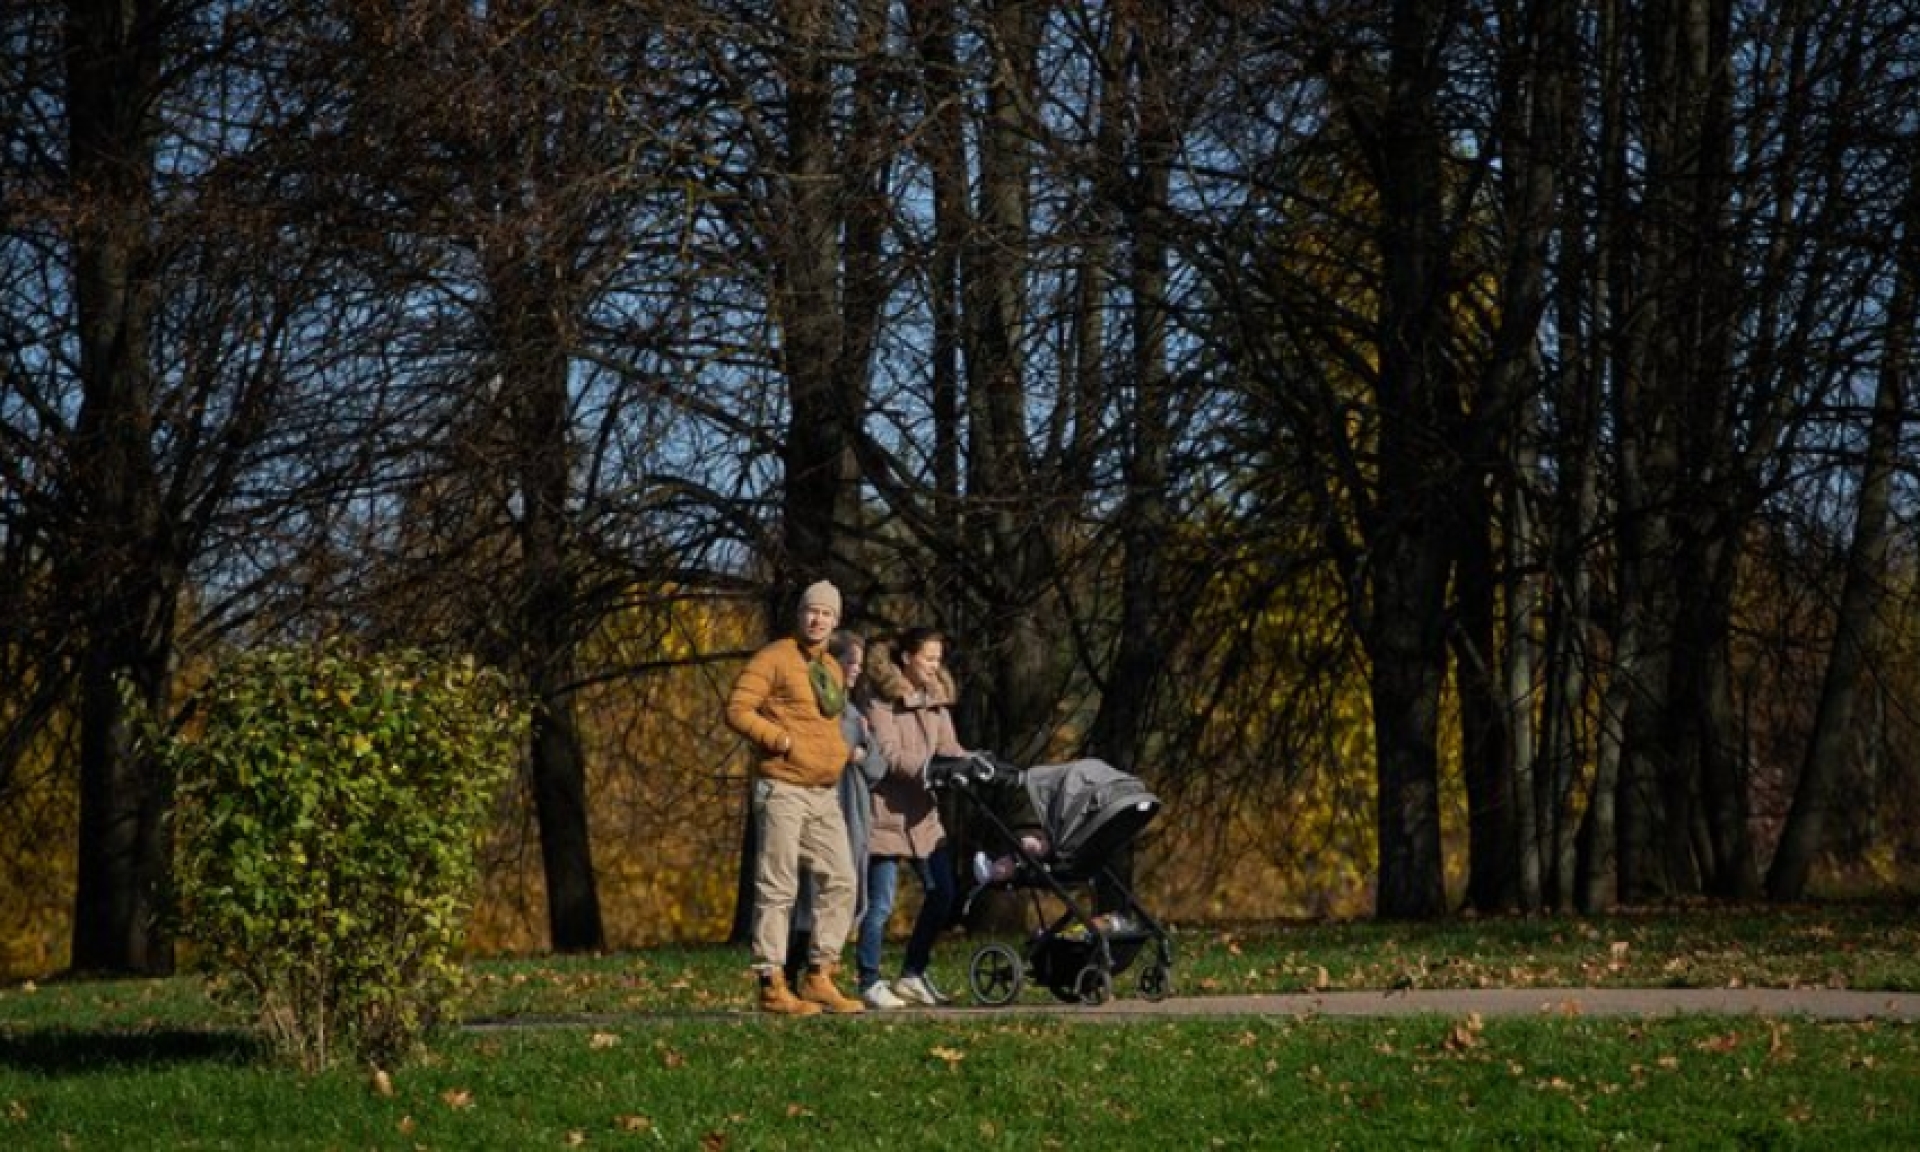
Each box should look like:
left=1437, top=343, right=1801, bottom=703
left=1615, top=0, right=1738, bottom=899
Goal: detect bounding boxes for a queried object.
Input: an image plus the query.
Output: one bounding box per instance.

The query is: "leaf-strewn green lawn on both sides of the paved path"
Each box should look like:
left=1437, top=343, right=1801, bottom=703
left=0, top=904, right=1920, bottom=1152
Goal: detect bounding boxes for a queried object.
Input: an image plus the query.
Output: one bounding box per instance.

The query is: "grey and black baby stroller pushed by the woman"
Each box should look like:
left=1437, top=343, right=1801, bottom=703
left=927, top=753, right=1173, bottom=1004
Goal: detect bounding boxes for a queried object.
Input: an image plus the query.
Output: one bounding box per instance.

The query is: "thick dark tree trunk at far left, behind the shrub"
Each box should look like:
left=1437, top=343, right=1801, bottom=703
left=61, top=0, right=179, bottom=973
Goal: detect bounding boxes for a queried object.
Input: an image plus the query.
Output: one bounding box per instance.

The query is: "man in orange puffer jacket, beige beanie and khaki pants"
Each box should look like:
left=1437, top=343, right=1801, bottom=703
left=726, top=580, right=864, bottom=1016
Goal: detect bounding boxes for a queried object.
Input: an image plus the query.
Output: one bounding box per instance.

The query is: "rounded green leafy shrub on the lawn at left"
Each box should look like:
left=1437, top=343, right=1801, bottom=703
left=163, top=645, right=526, bottom=1069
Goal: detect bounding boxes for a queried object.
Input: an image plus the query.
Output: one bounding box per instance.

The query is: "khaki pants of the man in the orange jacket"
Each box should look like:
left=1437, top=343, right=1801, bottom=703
left=753, top=780, right=858, bottom=968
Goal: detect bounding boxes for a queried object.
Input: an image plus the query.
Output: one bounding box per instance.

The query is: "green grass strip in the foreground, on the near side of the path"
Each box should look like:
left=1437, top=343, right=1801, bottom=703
left=0, top=1018, right=1920, bottom=1150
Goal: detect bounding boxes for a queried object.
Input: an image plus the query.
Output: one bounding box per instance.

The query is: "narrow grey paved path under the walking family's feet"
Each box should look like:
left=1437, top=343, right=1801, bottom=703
left=468, top=989, right=1920, bottom=1029
